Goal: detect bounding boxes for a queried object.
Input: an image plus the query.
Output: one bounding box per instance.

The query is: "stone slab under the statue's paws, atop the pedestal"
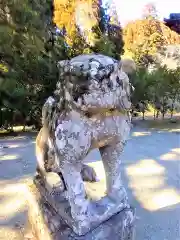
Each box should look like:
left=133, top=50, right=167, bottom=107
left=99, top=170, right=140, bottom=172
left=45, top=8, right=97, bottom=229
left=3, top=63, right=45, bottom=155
left=34, top=175, right=130, bottom=236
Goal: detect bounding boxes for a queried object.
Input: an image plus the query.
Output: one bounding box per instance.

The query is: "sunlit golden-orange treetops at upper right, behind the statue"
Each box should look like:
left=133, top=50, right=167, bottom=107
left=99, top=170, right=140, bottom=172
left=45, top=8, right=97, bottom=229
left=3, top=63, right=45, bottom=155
left=123, top=19, right=180, bottom=61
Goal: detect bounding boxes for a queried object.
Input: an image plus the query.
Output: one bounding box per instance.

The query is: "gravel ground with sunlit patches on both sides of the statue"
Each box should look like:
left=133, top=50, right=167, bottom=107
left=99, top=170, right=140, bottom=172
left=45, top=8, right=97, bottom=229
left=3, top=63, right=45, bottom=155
left=0, top=126, right=180, bottom=240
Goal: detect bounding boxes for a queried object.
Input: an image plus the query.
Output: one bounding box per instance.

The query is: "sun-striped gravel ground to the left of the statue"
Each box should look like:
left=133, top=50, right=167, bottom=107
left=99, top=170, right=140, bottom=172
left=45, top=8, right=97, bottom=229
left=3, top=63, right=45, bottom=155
left=0, top=137, right=35, bottom=240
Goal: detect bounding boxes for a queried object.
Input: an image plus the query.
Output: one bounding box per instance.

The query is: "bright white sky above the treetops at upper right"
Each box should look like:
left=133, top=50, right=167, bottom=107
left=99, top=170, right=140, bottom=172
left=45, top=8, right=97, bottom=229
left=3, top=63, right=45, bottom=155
left=103, top=0, right=180, bottom=26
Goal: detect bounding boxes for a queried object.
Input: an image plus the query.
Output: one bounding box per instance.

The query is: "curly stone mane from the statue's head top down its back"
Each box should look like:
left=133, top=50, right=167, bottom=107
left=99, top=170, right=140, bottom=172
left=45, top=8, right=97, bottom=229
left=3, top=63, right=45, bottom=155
left=43, top=54, right=134, bottom=136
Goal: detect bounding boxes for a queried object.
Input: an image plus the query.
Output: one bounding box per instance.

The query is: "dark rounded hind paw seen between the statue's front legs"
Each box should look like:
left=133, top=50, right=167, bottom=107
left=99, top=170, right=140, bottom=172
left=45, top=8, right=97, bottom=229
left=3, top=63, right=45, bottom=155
left=81, top=164, right=98, bottom=182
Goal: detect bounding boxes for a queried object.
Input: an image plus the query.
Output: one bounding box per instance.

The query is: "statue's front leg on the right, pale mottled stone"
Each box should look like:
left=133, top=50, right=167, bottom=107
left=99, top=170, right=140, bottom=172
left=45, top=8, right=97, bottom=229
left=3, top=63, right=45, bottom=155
left=99, top=142, right=127, bottom=202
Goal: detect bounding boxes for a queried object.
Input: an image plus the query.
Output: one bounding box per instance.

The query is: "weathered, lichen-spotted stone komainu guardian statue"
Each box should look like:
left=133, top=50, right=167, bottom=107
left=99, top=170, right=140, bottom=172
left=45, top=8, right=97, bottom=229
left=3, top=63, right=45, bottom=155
left=36, top=54, right=135, bottom=235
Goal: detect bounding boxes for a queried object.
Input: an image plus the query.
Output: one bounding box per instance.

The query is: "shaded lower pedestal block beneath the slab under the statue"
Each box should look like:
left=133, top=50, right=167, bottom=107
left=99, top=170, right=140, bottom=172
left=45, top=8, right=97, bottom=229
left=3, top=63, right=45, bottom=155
left=41, top=204, right=134, bottom=240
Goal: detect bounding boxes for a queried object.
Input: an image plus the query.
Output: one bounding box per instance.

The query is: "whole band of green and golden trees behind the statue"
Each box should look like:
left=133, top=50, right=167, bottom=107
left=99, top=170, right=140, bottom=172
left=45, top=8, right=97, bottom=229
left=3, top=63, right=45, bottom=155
left=0, top=0, right=180, bottom=127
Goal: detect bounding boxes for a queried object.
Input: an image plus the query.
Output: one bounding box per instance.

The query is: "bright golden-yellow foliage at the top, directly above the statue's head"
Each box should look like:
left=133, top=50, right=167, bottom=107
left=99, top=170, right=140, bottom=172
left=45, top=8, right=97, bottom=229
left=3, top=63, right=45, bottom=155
left=53, top=0, right=99, bottom=45
